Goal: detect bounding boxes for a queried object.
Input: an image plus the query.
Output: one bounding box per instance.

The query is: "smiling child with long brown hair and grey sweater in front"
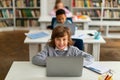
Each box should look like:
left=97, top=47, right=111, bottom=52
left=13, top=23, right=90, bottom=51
left=32, top=26, right=94, bottom=66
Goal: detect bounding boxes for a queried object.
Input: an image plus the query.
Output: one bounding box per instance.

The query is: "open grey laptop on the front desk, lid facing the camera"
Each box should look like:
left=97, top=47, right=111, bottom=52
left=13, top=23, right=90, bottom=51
left=46, top=56, right=83, bottom=77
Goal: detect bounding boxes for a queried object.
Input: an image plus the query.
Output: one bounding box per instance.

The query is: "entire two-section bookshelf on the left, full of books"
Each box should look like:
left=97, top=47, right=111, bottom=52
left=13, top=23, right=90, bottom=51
left=0, top=0, right=41, bottom=29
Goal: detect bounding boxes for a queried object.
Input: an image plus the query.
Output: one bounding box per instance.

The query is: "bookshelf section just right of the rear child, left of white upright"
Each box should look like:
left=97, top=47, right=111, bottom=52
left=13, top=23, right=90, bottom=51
left=71, top=0, right=102, bottom=20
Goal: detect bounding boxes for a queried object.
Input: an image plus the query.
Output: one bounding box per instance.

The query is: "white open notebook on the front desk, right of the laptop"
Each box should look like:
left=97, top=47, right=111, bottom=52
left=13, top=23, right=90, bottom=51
left=84, top=63, right=110, bottom=74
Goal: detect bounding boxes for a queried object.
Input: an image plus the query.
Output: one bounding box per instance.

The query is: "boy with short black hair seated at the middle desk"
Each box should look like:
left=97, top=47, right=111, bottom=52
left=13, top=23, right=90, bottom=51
left=53, top=9, right=76, bottom=34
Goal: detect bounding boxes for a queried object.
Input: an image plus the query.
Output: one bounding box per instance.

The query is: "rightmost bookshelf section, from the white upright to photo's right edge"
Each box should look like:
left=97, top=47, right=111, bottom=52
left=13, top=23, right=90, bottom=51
left=103, top=0, right=120, bottom=21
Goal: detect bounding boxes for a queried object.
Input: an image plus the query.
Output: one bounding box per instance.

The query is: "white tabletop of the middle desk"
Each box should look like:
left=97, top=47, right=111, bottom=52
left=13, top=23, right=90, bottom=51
left=24, top=30, right=105, bottom=43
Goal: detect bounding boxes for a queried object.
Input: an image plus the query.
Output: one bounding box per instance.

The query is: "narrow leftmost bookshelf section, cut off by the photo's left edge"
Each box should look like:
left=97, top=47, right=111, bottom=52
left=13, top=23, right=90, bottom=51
left=0, top=0, right=14, bottom=29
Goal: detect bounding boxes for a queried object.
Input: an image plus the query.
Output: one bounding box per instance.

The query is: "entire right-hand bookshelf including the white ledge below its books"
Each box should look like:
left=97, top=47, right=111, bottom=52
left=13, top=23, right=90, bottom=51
left=71, top=0, right=120, bottom=36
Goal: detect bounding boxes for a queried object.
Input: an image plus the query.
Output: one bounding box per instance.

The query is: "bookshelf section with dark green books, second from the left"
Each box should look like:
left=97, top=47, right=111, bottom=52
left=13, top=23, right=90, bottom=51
left=15, top=0, right=40, bottom=28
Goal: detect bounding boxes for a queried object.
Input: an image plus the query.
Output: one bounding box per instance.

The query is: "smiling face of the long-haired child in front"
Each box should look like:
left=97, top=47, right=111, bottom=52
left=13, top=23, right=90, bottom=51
left=55, top=35, right=68, bottom=50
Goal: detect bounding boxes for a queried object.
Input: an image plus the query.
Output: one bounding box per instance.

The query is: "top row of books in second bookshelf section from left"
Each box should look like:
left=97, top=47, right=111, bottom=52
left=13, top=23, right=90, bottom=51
left=15, top=0, right=40, bottom=7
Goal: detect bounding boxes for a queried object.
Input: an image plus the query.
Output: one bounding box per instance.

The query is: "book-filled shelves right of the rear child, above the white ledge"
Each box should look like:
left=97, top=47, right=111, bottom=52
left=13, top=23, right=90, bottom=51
left=71, top=0, right=120, bottom=21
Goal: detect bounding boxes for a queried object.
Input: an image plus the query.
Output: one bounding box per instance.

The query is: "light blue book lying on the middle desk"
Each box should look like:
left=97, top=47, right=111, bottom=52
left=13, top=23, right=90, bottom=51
left=27, top=32, right=49, bottom=39
